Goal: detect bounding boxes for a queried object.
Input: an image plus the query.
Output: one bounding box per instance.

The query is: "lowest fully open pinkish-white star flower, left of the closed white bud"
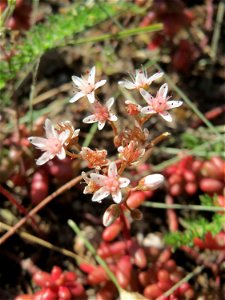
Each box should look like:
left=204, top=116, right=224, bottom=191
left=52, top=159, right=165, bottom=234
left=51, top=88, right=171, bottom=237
left=89, top=162, right=130, bottom=203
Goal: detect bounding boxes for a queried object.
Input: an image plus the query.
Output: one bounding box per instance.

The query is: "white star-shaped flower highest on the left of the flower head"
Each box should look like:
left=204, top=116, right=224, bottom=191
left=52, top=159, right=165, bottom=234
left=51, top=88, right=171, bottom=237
left=70, top=67, right=106, bottom=103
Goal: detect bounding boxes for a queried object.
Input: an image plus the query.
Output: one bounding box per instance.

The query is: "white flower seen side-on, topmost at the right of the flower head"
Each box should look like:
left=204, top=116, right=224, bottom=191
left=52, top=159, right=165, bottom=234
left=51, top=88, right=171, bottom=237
left=118, top=69, right=163, bottom=90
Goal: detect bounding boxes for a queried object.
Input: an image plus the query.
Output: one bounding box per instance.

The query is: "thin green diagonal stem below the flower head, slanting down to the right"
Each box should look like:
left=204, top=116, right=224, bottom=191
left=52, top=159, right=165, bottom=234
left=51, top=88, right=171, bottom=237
left=68, top=220, right=121, bottom=292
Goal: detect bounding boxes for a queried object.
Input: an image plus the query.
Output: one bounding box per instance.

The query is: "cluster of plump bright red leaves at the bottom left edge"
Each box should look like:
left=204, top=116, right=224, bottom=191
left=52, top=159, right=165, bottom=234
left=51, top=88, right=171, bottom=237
left=15, top=266, right=86, bottom=300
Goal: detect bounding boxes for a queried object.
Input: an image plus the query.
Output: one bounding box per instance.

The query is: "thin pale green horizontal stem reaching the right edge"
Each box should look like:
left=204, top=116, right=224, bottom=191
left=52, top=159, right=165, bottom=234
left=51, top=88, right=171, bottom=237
left=142, top=201, right=225, bottom=212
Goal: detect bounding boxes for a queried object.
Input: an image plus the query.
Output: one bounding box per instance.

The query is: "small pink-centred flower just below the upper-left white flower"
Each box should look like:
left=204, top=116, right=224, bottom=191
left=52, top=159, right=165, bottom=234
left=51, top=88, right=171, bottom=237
left=83, top=98, right=117, bottom=130
